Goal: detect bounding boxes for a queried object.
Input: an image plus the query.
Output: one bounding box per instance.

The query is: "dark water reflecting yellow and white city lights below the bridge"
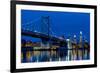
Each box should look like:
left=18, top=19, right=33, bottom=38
left=21, top=48, right=90, bottom=63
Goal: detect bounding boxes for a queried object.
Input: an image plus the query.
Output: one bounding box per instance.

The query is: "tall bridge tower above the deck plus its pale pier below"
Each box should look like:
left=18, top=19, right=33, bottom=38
left=41, top=16, right=50, bottom=48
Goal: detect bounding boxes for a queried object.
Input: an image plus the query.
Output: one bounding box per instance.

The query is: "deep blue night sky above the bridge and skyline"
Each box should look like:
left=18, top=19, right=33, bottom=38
left=21, top=10, right=90, bottom=42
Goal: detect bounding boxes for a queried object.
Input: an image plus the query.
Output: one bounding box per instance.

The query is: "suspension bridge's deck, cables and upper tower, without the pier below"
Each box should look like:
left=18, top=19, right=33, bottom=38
left=21, top=16, right=67, bottom=43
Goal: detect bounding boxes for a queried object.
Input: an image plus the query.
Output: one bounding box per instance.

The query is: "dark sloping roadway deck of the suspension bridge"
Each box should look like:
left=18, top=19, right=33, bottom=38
left=21, top=30, right=67, bottom=43
